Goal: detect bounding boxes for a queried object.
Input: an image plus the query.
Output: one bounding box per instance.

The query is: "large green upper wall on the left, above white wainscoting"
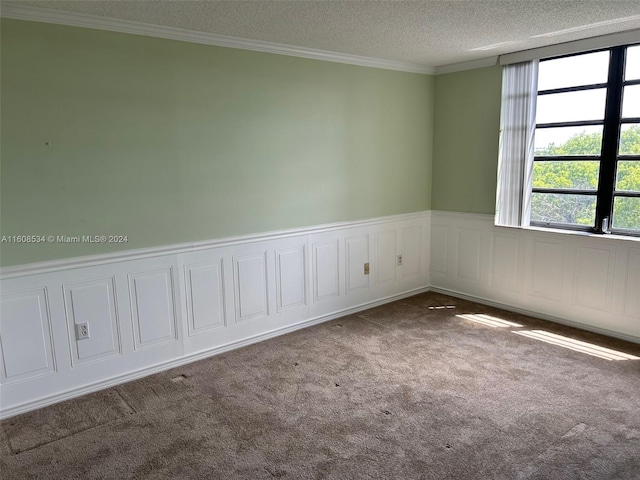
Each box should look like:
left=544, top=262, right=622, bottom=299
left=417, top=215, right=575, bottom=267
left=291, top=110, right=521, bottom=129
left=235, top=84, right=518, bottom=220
left=0, top=19, right=442, bottom=266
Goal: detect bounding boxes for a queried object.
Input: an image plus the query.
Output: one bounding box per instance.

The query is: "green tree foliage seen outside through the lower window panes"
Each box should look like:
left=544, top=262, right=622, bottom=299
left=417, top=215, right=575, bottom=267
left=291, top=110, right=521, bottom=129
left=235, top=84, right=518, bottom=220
left=531, top=125, right=640, bottom=230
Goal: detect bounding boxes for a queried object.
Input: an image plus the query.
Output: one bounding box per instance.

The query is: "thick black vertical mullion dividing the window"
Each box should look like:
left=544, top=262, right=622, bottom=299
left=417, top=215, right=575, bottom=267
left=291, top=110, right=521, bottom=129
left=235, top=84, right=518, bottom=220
left=595, top=47, right=625, bottom=233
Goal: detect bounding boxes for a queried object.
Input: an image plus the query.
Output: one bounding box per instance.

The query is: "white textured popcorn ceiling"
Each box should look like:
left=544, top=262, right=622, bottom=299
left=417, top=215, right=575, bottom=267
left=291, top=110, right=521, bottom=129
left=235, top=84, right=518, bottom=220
left=2, top=0, right=640, bottom=67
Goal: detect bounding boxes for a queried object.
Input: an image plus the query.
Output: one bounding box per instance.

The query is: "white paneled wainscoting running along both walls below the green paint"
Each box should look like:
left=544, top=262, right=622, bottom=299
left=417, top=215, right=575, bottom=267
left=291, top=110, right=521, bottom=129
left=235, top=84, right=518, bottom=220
left=0, top=211, right=640, bottom=418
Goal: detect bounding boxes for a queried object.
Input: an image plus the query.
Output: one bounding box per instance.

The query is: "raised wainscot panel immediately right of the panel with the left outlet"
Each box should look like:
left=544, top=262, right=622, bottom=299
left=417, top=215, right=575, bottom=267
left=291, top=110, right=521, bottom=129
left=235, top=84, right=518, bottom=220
left=129, top=267, right=177, bottom=350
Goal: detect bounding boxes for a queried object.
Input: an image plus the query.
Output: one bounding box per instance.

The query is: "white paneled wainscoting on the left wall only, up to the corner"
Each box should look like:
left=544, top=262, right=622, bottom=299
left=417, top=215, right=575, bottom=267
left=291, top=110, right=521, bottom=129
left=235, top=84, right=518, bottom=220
left=0, top=212, right=430, bottom=417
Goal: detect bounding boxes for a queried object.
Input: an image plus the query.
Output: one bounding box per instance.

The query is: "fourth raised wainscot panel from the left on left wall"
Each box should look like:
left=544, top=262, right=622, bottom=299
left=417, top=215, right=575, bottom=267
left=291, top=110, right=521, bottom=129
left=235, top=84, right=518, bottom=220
left=184, top=258, right=227, bottom=336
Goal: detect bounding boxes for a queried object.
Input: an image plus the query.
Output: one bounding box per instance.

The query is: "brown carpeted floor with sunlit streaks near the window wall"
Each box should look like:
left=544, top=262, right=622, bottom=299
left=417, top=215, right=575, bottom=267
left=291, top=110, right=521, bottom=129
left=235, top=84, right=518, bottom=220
left=0, top=293, right=640, bottom=480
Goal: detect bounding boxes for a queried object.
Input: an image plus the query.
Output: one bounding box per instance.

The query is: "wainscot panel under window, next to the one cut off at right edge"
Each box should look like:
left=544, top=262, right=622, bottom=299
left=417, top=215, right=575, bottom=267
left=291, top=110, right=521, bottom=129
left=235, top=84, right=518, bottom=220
left=573, top=245, right=615, bottom=311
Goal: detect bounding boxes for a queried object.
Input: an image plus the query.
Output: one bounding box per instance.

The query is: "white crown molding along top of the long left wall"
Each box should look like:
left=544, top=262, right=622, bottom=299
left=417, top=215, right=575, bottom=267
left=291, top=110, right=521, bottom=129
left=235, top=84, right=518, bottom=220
left=0, top=3, right=435, bottom=75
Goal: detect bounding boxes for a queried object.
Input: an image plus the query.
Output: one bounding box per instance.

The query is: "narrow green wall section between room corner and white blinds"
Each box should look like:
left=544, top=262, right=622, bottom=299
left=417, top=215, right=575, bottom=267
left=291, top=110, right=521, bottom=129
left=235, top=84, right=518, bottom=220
left=431, top=66, right=502, bottom=214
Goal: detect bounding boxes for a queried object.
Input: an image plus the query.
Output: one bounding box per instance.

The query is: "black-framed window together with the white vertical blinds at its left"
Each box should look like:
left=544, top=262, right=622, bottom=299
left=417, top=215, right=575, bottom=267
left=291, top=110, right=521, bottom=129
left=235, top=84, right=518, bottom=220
left=496, top=45, right=640, bottom=236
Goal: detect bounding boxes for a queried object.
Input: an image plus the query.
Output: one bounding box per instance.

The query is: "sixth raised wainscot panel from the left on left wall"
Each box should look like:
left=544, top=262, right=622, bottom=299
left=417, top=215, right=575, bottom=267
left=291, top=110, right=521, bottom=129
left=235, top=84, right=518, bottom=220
left=275, top=245, right=307, bottom=312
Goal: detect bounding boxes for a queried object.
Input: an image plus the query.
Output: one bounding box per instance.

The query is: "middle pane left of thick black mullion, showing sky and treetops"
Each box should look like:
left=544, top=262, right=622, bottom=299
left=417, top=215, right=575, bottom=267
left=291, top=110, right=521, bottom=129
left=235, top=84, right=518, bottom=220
left=535, top=125, right=602, bottom=156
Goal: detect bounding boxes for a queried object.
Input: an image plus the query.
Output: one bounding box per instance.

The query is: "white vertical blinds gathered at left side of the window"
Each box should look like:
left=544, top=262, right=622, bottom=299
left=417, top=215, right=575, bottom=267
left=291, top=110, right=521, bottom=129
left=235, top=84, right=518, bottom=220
left=495, top=60, right=538, bottom=227
